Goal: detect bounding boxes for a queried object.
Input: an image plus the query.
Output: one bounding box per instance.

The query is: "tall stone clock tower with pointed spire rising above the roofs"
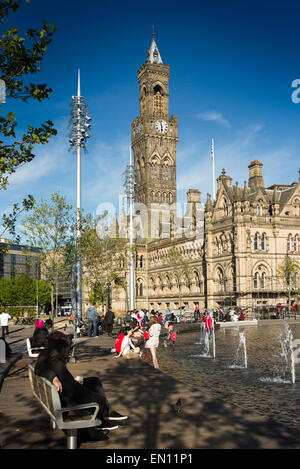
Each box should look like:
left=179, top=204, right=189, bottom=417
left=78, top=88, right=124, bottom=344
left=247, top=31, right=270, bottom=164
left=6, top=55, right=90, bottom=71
left=131, top=34, right=178, bottom=237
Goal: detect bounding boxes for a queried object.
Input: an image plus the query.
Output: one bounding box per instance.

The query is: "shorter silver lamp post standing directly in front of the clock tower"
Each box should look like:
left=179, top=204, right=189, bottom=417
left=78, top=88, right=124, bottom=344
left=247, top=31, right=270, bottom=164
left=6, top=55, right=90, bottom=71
left=124, top=146, right=136, bottom=311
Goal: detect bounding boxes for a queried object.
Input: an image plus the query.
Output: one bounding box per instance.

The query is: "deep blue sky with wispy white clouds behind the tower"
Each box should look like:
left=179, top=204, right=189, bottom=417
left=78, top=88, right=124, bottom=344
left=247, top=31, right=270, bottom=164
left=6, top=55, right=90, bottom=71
left=0, top=0, right=300, bottom=236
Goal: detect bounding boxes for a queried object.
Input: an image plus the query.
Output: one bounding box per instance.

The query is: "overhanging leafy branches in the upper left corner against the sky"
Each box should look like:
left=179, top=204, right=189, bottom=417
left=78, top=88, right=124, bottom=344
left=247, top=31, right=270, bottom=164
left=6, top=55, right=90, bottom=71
left=0, top=0, right=57, bottom=251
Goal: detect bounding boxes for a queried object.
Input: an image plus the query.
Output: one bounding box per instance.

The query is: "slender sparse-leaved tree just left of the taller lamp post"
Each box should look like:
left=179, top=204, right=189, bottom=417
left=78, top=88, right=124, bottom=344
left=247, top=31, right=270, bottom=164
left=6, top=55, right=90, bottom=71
left=22, top=193, right=76, bottom=314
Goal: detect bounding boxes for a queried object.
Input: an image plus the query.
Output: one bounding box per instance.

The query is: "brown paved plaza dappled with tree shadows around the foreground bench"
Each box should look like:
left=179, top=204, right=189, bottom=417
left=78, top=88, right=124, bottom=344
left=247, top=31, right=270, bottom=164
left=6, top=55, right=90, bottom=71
left=0, top=325, right=300, bottom=450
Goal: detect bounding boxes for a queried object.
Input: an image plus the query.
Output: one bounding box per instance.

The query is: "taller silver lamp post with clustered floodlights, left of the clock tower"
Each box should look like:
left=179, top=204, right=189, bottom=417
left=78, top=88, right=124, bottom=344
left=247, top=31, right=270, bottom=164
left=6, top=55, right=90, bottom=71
left=69, top=70, right=91, bottom=329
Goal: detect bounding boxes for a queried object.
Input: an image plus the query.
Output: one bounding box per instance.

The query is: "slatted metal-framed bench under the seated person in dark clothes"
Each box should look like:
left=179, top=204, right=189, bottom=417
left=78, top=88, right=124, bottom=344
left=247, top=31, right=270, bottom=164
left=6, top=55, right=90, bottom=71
left=28, top=364, right=102, bottom=449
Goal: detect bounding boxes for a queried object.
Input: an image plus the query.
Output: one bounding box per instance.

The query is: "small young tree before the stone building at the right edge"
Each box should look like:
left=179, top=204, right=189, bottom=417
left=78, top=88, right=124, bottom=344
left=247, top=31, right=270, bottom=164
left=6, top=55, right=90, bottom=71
left=277, top=254, right=300, bottom=312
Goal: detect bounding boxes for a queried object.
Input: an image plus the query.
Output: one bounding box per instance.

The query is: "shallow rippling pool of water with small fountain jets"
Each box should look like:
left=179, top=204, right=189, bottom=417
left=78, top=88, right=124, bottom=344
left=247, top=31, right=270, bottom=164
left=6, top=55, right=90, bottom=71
left=157, top=322, right=300, bottom=429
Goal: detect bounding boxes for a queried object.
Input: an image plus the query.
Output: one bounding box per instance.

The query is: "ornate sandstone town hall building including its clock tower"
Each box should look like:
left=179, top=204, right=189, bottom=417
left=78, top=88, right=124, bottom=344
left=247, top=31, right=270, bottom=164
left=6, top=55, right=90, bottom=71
left=88, top=38, right=300, bottom=313
